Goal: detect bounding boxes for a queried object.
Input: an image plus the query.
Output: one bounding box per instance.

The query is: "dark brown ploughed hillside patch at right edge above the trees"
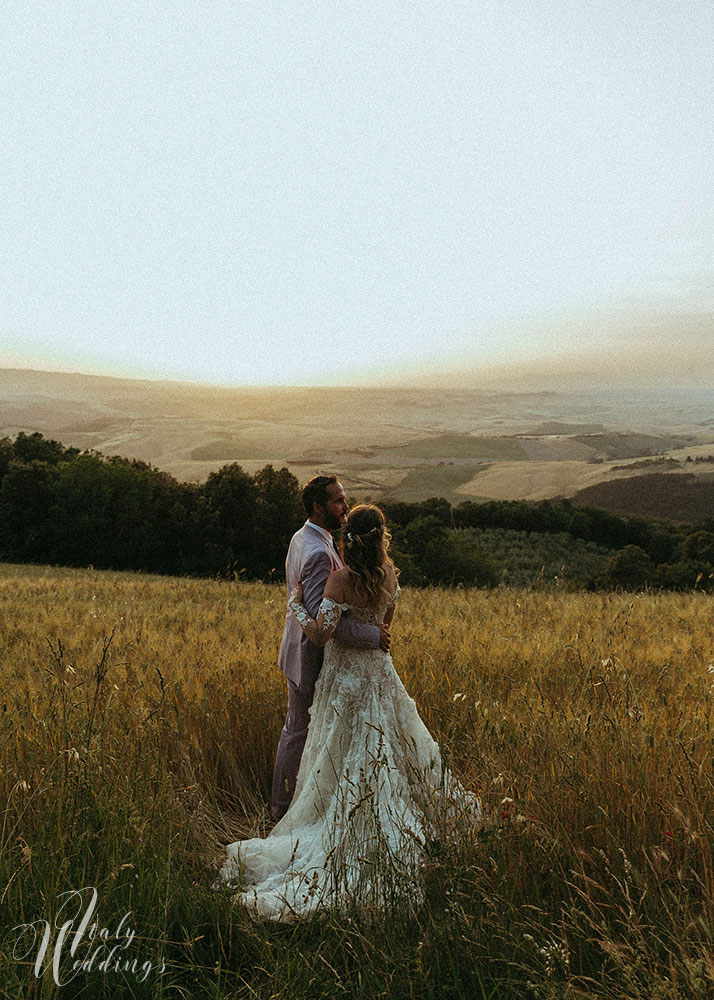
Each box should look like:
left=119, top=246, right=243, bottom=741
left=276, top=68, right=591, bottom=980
left=572, top=472, right=714, bottom=524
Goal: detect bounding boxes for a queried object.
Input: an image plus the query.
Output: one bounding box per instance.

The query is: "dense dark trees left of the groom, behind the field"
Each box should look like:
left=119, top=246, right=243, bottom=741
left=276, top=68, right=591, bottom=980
left=0, top=433, right=304, bottom=579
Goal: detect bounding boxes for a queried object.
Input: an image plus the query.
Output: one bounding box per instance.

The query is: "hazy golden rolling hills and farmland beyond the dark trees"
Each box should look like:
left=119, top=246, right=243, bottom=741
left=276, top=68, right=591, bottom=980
left=0, top=368, right=714, bottom=516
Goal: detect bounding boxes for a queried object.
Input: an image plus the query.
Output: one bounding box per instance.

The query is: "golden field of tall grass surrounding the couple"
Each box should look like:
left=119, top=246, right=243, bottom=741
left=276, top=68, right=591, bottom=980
left=0, top=566, right=714, bottom=1000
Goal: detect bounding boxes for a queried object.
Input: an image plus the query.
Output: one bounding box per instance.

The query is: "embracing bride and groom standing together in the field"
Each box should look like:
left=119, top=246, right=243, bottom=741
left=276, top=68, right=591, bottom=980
left=221, top=476, right=472, bottom=921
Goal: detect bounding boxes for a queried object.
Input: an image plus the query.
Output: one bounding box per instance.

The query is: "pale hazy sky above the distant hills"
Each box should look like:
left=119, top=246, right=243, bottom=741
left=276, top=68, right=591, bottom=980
left=0, top=0, right=714, bottom=384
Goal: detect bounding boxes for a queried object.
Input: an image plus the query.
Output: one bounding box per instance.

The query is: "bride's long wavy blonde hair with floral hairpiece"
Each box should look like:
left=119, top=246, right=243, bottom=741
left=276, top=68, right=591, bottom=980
left=342, top=503, right=399, bottom=606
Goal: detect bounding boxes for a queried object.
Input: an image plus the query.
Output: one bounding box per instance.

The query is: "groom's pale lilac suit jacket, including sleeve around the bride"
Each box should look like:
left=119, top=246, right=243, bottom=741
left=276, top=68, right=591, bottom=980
left=278, top=522, right=379, bottom=694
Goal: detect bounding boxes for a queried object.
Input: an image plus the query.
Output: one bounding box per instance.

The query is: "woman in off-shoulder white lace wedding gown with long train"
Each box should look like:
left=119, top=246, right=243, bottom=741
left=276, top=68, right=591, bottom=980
left=214, top=505, right=480, bottom=921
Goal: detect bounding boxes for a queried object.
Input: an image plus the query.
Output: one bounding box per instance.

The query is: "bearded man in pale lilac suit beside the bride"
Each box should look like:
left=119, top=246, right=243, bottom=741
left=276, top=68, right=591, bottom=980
left=271, top=476, right=390, bottom=819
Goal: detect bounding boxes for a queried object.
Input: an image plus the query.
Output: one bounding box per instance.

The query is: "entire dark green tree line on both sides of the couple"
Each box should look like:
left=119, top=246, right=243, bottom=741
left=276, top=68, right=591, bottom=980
left=0, top=433, right=714, bottom=589
